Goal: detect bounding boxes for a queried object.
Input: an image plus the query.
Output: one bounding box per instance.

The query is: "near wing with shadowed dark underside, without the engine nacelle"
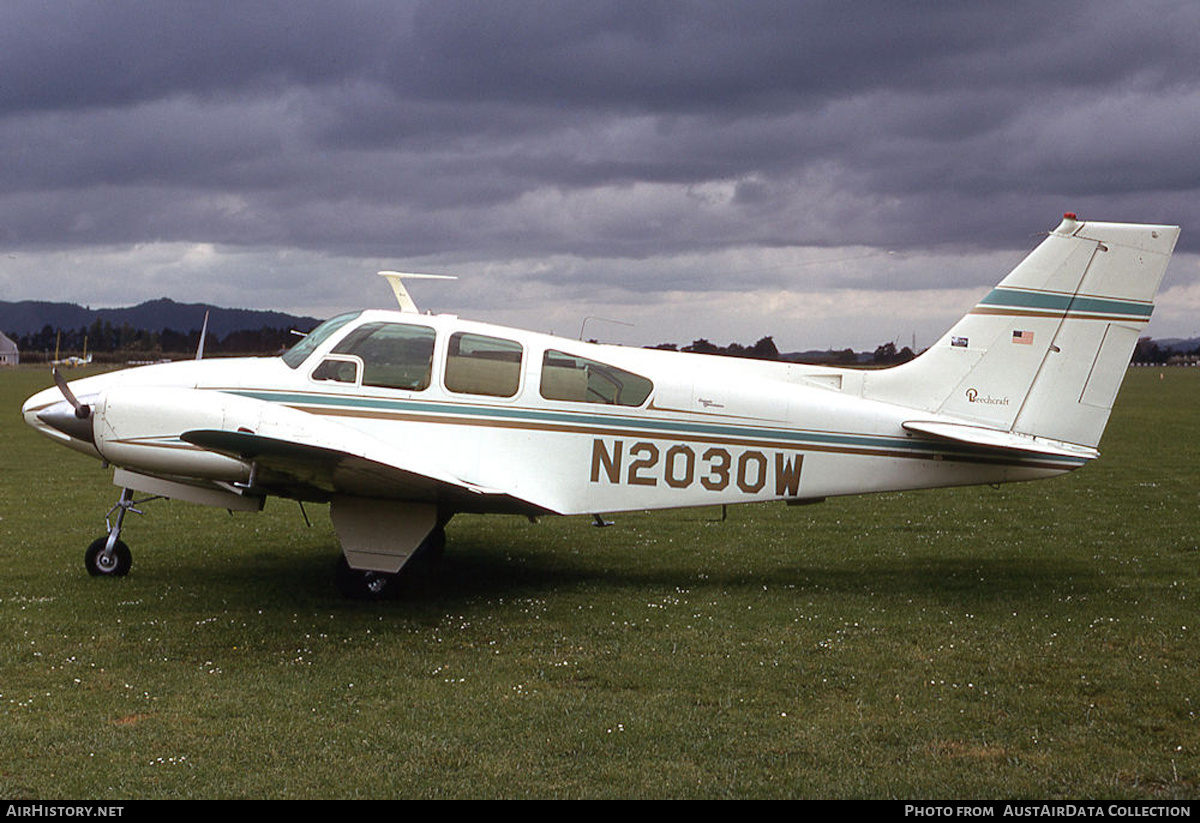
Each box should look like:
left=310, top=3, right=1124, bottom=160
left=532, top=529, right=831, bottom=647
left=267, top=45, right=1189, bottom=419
left=180, top=429, right=553, bottom=515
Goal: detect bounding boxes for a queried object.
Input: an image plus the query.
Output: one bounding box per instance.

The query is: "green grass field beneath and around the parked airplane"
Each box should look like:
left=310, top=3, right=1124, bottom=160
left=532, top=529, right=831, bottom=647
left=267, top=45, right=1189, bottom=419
left=0, top=368, right=1200, bottom=800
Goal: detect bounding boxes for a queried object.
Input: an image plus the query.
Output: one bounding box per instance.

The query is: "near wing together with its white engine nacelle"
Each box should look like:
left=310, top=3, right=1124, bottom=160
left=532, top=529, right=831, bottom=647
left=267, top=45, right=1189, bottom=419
left=70, top=385, right=553, bottom=515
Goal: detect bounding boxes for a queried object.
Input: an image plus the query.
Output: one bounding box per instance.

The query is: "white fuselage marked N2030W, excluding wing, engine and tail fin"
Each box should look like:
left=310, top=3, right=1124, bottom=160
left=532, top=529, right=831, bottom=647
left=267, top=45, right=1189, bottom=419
left=18, top=311, right=1085, bottom=523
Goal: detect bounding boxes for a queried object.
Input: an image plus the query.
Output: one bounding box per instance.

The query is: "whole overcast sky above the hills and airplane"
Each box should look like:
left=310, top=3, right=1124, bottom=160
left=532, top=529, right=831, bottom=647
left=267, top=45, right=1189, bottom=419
left=0, top=0, right=1200, bottom=350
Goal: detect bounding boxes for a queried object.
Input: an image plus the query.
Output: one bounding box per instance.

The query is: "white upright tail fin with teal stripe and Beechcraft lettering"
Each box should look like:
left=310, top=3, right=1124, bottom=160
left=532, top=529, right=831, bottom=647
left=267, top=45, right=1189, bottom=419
left=864, top=214, right=1180, bottom=449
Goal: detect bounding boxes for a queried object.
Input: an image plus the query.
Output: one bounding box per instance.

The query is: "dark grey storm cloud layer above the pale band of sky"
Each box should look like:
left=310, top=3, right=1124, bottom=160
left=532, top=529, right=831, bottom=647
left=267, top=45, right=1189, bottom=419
left=0, top=0, right=1200, bottom=271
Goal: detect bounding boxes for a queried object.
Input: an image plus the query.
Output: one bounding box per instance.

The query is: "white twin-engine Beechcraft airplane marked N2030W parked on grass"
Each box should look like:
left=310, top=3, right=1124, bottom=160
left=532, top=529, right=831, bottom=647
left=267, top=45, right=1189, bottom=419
left=23, top=214, right=1180, bottom=596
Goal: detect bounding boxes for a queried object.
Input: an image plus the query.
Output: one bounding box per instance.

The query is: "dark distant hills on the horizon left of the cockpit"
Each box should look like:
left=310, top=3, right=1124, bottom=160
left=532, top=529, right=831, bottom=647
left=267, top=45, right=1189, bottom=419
left=0, top=298, right=319, bottom=337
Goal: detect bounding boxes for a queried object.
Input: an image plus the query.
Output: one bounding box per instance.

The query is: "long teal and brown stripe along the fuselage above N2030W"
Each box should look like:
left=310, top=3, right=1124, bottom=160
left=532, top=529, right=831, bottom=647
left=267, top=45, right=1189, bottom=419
left=229, top=390, right=1087, bottom=468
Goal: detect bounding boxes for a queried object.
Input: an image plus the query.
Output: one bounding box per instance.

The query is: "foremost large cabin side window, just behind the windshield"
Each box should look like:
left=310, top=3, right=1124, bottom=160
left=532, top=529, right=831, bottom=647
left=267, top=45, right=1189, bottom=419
left=334, top=323, right=436, bottom=391
